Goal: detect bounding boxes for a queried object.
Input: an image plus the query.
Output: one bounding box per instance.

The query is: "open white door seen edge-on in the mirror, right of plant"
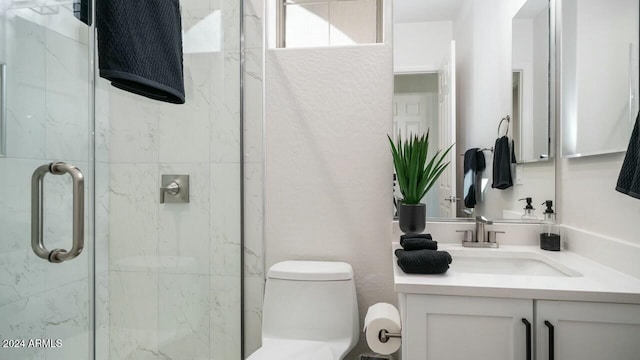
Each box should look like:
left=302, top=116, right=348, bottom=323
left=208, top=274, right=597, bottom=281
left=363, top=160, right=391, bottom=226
left=438, top=41, right=458, bottom=217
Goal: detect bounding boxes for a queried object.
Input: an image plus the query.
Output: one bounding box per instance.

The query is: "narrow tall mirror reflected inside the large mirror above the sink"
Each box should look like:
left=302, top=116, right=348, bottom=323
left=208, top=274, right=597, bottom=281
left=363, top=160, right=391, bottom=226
left=511, top=0, right=552, bottom=163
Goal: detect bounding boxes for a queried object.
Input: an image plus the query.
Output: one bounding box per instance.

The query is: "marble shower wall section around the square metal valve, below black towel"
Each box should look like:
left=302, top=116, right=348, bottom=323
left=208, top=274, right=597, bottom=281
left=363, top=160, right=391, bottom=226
left=96, top=0, right=241, bottom=360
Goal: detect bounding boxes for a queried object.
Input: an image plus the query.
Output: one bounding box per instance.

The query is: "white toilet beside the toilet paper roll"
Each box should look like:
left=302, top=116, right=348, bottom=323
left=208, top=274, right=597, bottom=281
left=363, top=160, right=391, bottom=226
left=247, top=261, right=359, bottom=360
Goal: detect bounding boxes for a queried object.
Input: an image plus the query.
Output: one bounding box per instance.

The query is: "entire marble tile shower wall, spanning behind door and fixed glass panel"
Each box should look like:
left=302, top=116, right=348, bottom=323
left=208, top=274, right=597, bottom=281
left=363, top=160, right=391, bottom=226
left=0, top=0, right=264, bottom=359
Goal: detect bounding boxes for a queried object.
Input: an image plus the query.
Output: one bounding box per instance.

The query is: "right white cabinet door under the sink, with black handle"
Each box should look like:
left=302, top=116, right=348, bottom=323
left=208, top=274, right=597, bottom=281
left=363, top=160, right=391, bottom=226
left=536, top=301, right=640, bottom=360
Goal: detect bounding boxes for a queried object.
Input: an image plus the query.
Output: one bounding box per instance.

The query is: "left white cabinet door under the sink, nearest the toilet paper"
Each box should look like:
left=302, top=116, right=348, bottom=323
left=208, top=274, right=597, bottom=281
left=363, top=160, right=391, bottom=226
left=402, top=295, right=533, bottom=360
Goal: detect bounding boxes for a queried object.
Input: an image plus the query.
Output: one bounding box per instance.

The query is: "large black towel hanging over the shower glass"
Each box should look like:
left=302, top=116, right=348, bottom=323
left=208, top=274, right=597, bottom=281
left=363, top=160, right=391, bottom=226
left=96, top=0, right=185, bottom=104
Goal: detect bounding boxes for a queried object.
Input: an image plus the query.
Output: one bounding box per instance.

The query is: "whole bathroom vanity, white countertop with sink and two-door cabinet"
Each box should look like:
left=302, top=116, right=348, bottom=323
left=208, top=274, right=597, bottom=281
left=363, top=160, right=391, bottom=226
left=393, top=243, right=640, bottom=360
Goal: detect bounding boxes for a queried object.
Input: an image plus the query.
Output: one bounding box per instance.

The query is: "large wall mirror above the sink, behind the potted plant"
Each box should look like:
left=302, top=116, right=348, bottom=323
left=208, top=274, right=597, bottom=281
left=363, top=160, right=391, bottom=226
left=393, top=0, right=555, bottom=222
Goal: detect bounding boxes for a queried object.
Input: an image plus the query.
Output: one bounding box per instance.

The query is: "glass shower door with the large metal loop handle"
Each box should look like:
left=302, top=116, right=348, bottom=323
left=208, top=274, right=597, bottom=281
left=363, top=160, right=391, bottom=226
left=0, top=0, right=94, bottom=360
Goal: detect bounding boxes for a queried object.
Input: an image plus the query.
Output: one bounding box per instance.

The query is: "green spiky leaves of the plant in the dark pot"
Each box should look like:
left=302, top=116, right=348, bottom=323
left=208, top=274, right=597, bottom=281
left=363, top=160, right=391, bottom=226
left=387, top=131, right=453, bottom=205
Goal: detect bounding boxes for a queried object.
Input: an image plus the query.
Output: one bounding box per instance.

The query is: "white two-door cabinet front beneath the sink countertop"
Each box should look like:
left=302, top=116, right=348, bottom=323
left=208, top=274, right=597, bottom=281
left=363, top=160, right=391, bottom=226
left=400, top=294, right=640, bottom=360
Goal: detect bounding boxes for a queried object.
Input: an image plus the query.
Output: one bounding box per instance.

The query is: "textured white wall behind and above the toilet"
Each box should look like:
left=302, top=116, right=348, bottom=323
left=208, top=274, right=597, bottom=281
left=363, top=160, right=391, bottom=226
left=265, top=44, right=396, bottom=354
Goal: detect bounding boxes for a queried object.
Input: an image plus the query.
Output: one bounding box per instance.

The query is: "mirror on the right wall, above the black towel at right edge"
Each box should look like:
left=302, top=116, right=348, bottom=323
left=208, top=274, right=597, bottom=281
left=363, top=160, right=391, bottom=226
left=559, top=0, right=640, bottom=157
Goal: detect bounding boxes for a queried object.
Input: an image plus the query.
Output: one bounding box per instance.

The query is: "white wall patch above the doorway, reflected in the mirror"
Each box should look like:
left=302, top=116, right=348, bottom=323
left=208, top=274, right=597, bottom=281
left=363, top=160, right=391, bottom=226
left=393, top=21, right=453, bottom=72
